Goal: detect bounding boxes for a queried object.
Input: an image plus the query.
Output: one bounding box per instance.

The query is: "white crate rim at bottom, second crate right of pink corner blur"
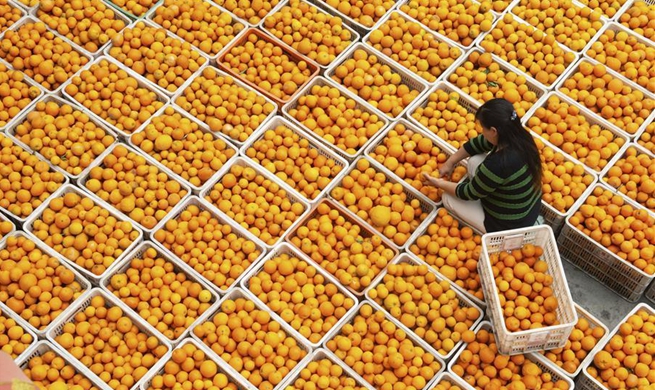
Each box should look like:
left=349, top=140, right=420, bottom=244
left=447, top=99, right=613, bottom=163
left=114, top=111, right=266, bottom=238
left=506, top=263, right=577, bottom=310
left=46, top=288, right=171, bottom=390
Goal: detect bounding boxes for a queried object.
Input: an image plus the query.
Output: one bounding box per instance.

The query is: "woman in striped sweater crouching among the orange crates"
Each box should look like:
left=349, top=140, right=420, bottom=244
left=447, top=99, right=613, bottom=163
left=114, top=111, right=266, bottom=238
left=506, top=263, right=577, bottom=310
left=424, top=99, right=542, bottom=232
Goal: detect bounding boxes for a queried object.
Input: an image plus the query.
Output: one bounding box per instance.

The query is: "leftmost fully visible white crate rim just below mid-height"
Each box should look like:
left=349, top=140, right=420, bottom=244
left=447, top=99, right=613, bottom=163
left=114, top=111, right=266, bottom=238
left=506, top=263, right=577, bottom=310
left=23, top=185, right=143, bottom=286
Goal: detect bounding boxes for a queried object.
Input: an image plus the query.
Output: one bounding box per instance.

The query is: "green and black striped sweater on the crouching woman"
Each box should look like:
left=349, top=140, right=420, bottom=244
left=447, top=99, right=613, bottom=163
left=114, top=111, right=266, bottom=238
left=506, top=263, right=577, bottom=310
left=456, top=135, right=541, bottom=232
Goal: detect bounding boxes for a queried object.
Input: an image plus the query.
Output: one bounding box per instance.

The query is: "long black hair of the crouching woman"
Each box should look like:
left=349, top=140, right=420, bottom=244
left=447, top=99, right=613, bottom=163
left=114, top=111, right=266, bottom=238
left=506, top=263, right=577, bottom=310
left=475, top=99, right=542, bottom=188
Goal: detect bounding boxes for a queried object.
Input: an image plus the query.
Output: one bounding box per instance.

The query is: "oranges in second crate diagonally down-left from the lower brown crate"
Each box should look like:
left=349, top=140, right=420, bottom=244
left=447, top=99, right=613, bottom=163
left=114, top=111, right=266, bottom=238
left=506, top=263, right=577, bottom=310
left=193, top=296, right=307, bottom=390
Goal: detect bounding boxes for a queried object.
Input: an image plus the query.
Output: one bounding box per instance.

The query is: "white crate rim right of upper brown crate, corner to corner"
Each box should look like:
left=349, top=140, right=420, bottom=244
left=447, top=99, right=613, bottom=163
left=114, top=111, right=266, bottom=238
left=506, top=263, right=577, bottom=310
left=324, top=43, right=428, bottom=120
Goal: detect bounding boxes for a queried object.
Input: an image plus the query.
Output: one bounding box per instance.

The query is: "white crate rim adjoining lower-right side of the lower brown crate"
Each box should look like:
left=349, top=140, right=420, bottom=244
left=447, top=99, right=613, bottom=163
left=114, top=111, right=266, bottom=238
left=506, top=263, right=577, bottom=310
left=366, top=253, right=484, bottom=361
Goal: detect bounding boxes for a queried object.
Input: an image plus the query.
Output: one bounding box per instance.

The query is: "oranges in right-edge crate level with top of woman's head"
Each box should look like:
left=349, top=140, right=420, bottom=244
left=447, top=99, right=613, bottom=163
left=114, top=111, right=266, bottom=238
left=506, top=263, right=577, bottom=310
left=559, top=60, right=655, bottom=134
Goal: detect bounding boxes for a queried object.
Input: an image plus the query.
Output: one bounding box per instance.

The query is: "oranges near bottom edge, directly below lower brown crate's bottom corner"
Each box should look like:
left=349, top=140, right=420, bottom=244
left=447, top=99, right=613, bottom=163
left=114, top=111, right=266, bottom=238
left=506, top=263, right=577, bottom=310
left=326, top=304, right=441, bottom=390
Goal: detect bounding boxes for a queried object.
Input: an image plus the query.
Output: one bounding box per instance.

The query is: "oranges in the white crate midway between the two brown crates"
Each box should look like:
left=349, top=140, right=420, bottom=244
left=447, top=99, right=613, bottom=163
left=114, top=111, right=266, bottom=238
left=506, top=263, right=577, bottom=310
left=245, top=125, right=343, bottom=200
